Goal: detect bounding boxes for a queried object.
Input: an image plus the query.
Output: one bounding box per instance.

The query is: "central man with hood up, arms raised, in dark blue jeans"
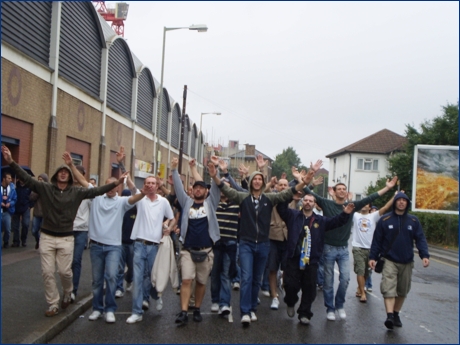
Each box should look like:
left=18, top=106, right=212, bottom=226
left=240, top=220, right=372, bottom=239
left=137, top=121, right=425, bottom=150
left=209, top=161, right=322, bottom=326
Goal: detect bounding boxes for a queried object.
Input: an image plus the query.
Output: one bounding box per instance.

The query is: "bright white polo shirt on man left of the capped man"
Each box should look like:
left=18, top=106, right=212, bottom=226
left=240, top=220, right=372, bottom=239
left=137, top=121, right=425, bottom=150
left=131, top=194, right=174, bottom=243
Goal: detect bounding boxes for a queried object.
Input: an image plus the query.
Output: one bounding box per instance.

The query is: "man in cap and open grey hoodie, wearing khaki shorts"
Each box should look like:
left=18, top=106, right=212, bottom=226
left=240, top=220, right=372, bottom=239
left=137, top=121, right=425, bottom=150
left=171, top=158, right=220, bottom=325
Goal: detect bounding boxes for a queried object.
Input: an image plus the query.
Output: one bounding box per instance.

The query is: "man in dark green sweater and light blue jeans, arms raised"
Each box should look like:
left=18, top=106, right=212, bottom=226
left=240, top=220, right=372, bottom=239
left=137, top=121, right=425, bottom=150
left=304, top=176, right=398, bottom=321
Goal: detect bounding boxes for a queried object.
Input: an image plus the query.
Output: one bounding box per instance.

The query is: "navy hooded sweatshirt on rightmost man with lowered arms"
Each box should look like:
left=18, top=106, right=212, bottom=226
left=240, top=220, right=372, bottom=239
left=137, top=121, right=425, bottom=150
left=369, top=192, right=430, bottom=264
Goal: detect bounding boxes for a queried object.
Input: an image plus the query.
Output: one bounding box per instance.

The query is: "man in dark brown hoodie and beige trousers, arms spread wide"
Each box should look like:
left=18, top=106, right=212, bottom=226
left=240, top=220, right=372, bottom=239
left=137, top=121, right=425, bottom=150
left=2, top=146, right=125, bottom=316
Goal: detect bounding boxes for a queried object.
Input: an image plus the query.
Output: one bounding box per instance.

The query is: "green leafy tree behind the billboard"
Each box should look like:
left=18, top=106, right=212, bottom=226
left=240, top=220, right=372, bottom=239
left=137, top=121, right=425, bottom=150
left=388, top=102, right=458, bottom=197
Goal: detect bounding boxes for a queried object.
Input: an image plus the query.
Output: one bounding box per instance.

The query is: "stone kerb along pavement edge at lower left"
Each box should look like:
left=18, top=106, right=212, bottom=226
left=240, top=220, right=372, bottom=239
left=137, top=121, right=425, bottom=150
left=21, top=293, right=93, bottom=344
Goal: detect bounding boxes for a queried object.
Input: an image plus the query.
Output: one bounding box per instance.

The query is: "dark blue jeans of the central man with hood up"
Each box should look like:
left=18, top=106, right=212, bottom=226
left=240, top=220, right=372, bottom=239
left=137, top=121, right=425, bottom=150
left=240, top=240, right=270, bottom=316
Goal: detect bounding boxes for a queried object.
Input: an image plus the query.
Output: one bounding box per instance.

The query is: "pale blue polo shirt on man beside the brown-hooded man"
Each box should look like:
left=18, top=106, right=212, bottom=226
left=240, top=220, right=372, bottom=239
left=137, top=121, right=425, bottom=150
left=89, top=194, right=134, bottom=246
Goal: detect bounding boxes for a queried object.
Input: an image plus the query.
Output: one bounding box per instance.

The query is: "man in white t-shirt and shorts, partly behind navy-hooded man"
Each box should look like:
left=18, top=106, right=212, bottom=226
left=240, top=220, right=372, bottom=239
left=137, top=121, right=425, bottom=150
left=351, top=198, right=393, bottom=303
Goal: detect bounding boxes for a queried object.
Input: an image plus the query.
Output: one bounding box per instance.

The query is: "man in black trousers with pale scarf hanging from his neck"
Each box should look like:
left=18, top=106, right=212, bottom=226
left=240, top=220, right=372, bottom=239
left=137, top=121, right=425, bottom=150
left=277, top=194, right=354, bottom=325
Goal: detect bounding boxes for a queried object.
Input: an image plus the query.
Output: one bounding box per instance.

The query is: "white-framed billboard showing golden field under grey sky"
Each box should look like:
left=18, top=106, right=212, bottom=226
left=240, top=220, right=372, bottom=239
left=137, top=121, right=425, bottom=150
left=412, top=145, right=458, bottom=214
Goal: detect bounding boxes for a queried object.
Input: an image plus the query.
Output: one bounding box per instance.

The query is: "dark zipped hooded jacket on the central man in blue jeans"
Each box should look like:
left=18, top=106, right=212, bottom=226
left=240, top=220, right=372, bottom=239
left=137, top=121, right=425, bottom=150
left=218, top=171, right=296, bottom=243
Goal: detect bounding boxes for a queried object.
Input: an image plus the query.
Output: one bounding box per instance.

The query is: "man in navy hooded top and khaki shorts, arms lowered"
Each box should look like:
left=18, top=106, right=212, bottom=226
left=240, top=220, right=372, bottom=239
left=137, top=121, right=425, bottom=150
left=369, top=192, right=430, bottom=329
